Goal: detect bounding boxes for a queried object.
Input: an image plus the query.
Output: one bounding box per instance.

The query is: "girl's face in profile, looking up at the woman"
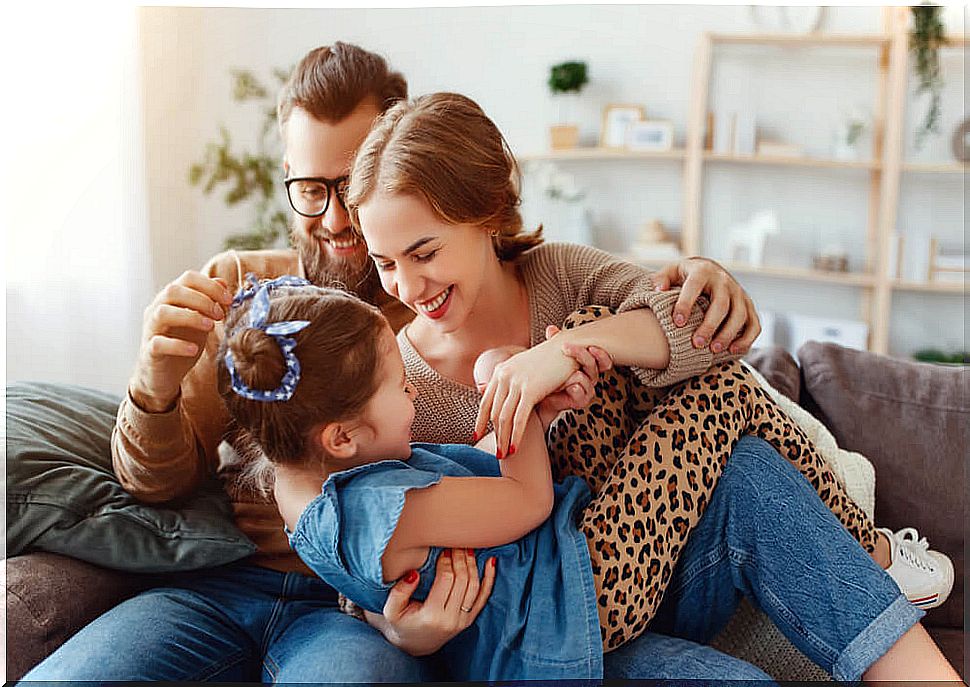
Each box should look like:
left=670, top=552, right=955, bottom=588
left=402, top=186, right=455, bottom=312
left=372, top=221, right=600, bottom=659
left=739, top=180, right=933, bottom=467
left=357, top=327, right=417, bottom=463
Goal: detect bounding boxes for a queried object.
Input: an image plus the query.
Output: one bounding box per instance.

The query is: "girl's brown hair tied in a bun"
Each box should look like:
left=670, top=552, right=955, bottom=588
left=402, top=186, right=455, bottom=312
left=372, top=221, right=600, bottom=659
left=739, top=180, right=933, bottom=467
left=218, top=286, right=387, bottom=492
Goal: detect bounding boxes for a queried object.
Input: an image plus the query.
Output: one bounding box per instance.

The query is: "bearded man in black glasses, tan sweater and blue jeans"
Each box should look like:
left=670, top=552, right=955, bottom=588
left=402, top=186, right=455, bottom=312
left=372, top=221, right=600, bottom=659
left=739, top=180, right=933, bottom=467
left=17, top=42, right=832, bottom=682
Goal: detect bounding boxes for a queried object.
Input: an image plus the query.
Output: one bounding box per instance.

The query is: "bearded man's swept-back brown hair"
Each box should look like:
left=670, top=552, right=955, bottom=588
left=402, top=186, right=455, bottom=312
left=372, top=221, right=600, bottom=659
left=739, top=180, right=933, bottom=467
left=276, top=41, right=408, bottom=129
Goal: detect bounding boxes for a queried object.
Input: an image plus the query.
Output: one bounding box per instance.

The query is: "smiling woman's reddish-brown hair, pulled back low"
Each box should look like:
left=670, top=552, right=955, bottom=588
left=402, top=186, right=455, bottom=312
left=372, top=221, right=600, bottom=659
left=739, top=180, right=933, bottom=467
left=347, top=93, right=542, bottom=260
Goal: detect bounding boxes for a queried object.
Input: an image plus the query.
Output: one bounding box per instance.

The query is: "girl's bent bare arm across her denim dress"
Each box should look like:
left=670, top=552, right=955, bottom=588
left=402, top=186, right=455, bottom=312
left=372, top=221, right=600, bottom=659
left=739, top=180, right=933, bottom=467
left=382, top=413, right=553, bottom=579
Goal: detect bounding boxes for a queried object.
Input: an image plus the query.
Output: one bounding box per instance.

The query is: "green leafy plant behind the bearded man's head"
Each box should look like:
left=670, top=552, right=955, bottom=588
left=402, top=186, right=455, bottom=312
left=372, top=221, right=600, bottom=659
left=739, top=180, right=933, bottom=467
left=189, top=69, right=289, bottom=250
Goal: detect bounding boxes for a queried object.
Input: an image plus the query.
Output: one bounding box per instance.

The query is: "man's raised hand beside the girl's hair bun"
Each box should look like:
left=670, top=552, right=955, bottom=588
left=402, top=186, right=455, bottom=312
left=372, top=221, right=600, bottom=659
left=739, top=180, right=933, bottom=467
left=128, top=271, right=232, bottom=413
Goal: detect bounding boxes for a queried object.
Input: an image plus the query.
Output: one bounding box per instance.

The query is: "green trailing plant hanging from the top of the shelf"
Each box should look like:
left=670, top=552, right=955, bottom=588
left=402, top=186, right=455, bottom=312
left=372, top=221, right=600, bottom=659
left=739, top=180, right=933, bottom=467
left=909, top=4, right=949, bottom=148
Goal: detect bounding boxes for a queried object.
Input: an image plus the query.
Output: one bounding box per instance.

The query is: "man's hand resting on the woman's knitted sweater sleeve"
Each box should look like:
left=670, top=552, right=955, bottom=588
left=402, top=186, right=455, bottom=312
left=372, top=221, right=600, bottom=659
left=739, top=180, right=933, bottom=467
left=652, top=257, right=761, bottom=354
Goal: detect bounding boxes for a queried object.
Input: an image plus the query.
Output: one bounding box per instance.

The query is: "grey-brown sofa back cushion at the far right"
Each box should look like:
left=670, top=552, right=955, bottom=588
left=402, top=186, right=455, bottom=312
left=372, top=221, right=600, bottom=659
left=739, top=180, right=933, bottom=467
left=798, top=342, right=970, bottom=628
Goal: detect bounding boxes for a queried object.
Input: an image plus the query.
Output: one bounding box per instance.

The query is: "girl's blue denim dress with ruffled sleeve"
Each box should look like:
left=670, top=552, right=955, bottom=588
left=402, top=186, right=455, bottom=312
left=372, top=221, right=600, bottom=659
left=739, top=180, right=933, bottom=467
left=287, top=444, right=603, bottom=680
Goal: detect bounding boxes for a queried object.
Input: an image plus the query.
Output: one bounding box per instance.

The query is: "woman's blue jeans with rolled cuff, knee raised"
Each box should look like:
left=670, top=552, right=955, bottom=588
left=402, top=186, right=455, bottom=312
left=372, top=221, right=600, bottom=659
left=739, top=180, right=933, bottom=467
left=605, top=437, right=924, bottom=681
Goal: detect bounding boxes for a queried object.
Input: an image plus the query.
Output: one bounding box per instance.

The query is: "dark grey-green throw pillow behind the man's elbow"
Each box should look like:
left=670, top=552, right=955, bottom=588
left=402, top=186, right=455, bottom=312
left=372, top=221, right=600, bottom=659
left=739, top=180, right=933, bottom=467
left=7, top=382, right=256, bottom=572
